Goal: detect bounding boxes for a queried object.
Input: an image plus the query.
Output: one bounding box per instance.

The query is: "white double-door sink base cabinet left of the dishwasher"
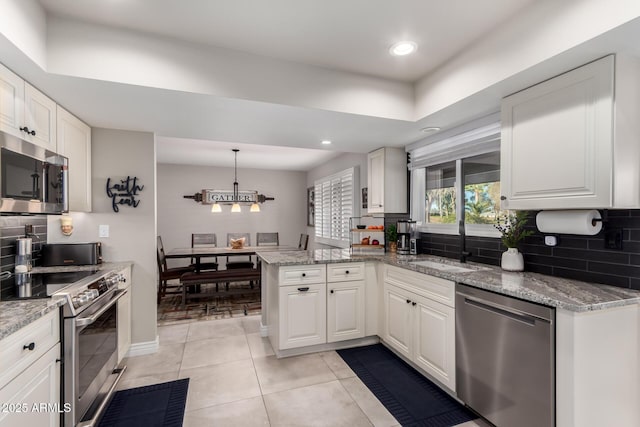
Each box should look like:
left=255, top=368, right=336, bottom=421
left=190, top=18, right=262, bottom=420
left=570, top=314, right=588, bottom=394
left=382, top=267, right=456, bottom=392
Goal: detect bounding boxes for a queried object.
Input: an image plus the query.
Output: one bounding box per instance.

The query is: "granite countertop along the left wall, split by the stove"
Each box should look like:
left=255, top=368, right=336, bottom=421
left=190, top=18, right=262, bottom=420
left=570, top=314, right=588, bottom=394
left=0, top=262, right=133, bottom=339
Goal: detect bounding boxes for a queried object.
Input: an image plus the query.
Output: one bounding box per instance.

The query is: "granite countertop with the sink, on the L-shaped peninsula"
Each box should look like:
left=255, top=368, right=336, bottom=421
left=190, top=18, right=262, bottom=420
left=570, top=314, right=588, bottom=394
left=258, top=249, right=640, bottom=312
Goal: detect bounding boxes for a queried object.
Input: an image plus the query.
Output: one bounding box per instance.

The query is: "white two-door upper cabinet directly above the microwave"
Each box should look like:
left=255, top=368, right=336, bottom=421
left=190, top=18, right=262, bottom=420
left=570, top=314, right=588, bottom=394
left=0, top=65, right=56, bottom=151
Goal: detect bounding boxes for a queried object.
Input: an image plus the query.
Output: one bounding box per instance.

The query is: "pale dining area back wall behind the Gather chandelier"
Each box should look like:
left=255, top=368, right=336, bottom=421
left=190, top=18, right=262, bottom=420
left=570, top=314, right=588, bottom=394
left=158, top=163, right=306, bottom=265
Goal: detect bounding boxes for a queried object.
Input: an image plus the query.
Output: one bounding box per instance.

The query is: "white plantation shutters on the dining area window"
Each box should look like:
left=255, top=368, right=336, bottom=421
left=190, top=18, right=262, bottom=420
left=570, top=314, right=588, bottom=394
left=315, top=168, right=356, bottom=248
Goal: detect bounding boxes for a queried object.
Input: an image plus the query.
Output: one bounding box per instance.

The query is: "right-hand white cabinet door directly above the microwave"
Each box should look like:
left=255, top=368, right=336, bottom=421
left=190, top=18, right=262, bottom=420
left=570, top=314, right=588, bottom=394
left=24, top=82, right=57, bottom=152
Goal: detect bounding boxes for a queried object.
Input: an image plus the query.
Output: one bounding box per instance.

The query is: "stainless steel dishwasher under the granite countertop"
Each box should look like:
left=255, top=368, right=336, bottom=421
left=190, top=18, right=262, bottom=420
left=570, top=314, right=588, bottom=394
left=456, top=284, right=555, bottom=427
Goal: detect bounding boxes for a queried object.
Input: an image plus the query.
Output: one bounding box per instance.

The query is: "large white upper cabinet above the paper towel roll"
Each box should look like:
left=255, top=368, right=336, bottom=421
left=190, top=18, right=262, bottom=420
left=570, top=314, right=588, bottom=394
left=501, top=56, right=640, bottom=209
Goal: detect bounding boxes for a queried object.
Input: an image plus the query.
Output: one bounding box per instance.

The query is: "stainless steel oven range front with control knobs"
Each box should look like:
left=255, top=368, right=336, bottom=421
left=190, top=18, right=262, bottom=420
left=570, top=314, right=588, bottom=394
left=52, top=271, right=127, bottom=427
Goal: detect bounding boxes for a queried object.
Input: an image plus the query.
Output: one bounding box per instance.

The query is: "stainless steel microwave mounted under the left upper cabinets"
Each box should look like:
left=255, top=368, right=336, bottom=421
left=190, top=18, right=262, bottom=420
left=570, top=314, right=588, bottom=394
left=0, top=132, right=69, bottom=214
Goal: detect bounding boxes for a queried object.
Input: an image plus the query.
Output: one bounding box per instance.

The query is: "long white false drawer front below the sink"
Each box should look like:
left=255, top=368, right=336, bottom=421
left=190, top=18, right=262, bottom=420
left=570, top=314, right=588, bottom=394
left=384, top=265, right=456, bottom=307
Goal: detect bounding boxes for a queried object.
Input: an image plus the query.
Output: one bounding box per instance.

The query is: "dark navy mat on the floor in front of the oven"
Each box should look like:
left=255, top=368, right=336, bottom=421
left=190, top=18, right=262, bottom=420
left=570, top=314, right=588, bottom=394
left=98, top=378, right=189, bottom=427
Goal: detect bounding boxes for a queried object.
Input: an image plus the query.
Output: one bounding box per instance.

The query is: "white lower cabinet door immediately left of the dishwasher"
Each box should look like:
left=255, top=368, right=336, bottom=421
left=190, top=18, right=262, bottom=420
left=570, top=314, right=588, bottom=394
left=412, top=295, right=456, bottom=391
